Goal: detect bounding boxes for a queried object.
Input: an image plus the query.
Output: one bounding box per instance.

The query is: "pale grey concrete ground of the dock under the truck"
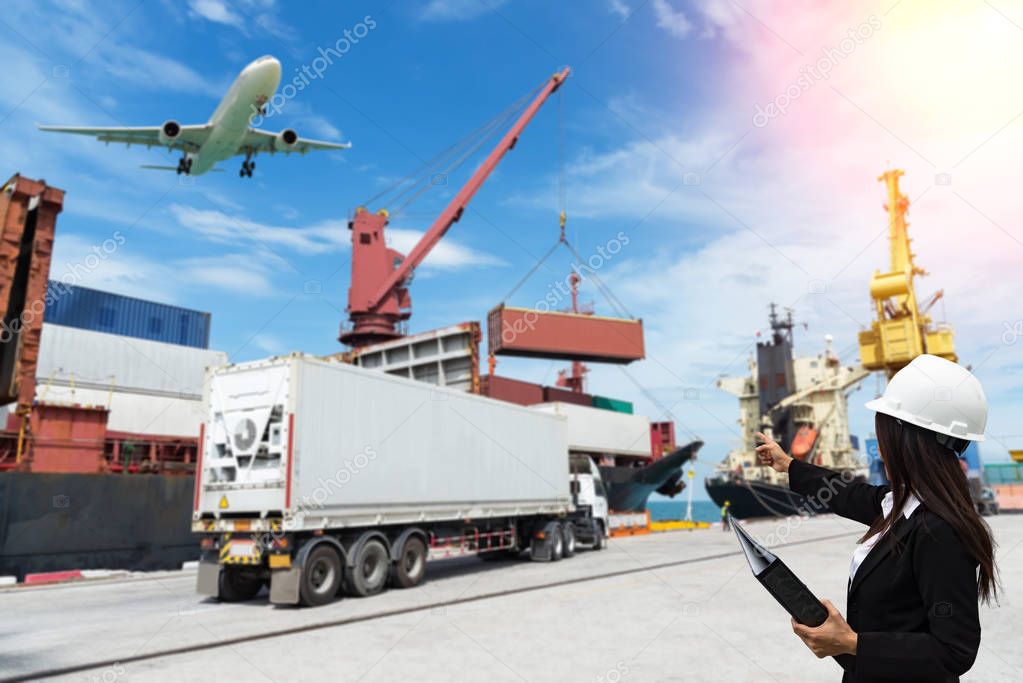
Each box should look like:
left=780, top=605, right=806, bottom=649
left=0, top=515, right=1023, bottom=683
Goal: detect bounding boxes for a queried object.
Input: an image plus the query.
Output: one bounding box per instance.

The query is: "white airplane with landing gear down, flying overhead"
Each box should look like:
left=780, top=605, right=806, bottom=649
left=38, top=55, right=352, bottom=178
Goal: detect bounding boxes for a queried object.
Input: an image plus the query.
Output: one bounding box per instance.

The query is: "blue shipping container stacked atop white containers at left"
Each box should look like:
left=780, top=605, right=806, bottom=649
left=43, top=280, right=210, bottom=349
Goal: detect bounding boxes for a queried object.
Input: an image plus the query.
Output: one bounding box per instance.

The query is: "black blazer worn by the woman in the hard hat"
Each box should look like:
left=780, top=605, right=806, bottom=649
left=789, top=460, right=980, bottom=682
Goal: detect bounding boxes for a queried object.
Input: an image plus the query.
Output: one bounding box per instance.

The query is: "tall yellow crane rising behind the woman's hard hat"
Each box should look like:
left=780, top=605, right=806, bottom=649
left=859, top=169, right=958, bottom=377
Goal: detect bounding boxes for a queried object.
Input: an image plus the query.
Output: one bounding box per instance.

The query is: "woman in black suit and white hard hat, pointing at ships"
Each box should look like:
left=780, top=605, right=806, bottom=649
left=757, top=356, right=996, bottom=681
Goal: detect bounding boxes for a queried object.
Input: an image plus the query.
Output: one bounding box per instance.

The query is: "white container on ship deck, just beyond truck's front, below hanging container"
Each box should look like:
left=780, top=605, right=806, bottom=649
left=530, top=402, right=651, bottom=457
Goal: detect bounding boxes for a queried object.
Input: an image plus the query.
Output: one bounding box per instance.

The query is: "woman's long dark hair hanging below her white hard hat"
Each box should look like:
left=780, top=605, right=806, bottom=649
left=860, top=413, right=997, bottom=602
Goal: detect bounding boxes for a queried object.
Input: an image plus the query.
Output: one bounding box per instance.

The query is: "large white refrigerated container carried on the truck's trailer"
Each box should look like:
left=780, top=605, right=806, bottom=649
left=196, top=354, right=571, bottom=531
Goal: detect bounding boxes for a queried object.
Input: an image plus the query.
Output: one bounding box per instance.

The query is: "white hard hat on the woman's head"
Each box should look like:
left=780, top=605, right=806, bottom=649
left=866, top=354, right=987, bottom=441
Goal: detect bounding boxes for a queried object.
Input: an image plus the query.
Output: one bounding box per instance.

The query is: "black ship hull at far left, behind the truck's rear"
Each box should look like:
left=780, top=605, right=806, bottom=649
left=0, top=472, right=199, bottom=580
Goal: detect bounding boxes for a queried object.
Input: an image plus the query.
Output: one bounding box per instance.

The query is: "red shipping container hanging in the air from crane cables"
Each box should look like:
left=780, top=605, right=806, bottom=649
left=487, top=305, right=646, bottom=364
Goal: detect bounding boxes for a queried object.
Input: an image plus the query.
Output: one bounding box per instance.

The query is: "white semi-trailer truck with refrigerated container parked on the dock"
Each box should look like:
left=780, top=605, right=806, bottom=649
left=192, top=354, right=608, bottom=605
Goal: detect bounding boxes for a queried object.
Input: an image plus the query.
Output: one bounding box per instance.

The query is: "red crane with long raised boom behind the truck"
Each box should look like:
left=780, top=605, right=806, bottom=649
left=340, top=67, right=570, bottom=347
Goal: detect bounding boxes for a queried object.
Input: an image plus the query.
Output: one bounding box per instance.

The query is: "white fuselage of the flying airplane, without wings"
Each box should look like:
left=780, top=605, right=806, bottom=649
left=186, top=56, right=280, bottom=176
